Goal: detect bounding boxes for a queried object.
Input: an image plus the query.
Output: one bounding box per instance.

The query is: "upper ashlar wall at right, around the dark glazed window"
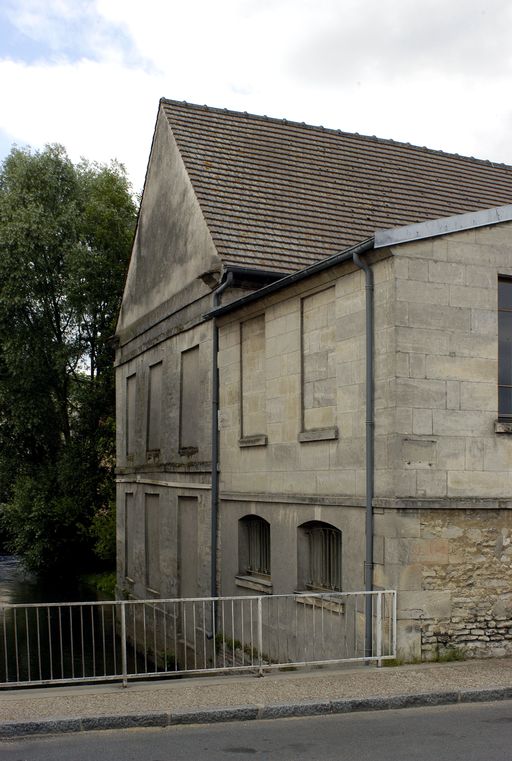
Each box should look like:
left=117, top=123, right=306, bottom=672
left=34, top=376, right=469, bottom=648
left=388, top=223, right=512, bottom=499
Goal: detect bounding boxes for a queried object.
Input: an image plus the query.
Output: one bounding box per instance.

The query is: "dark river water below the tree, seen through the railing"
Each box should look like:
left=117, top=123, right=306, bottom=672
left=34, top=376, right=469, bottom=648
left=0, top=555, right=154, bottom=686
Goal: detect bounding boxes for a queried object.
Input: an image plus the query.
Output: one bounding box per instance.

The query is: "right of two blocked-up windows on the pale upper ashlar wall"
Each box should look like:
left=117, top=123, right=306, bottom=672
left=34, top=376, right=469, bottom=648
left=302, top=288, right=336, bottom=431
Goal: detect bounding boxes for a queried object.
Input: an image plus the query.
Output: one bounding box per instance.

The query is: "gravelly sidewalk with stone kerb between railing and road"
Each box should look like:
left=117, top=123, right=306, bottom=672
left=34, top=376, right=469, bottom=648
left=0, top=658, right=512, bottom=738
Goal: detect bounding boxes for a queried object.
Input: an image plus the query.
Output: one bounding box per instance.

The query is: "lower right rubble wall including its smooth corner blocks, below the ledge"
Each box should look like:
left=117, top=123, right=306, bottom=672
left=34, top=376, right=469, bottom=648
left=375, top=505, right=512, bottom=659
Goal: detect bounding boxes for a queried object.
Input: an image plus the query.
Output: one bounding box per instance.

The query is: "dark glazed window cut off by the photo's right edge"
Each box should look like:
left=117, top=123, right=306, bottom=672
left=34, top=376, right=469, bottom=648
left=498, top=277, right=512, bottom=420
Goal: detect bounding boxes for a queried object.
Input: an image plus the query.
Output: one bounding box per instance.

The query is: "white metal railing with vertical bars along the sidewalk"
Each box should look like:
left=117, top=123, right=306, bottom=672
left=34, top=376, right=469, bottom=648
left=0, top=591, right=396, bottom=687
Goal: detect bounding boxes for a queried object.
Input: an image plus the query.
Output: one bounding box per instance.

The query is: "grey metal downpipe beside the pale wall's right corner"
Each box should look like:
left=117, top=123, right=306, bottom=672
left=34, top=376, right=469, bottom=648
left=352, top=253, right=375, bottom=657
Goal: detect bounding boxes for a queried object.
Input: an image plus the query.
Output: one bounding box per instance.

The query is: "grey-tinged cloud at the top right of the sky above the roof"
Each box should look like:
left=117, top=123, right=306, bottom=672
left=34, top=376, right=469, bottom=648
left=290, top=0, right=512, bottom=83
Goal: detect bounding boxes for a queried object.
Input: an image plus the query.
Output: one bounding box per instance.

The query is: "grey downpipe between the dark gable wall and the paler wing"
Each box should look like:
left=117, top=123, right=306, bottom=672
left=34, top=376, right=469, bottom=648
left=210, top=272, right=233, bottom=597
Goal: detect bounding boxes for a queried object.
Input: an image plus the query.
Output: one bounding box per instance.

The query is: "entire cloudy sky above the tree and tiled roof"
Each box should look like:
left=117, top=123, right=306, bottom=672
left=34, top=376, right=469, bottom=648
left=0, top=0, right=512, bottom=191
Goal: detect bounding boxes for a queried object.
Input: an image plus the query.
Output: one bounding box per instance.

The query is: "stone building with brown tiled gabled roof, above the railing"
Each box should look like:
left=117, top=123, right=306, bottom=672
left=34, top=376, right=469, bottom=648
left=116, top=100, right=512, bottom=657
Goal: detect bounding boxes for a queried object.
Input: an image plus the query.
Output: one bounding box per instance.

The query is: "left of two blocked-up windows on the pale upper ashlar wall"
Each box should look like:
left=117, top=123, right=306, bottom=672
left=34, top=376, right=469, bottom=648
left=240, top=315, right=267, bottom=437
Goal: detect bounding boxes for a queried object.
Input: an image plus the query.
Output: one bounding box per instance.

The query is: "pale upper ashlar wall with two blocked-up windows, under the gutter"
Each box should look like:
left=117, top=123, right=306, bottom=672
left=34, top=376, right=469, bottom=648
left=219, top=254, right=395, bottom=505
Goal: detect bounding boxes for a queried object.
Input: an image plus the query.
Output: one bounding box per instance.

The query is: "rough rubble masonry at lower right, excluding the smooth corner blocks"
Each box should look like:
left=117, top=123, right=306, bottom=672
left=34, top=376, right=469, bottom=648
left=420, top=509, right=512, bottom=660
